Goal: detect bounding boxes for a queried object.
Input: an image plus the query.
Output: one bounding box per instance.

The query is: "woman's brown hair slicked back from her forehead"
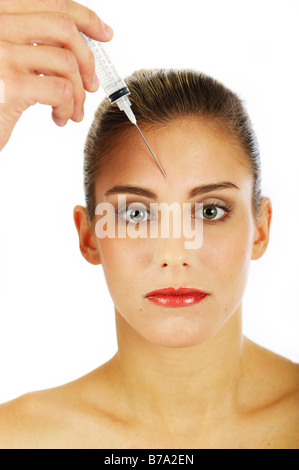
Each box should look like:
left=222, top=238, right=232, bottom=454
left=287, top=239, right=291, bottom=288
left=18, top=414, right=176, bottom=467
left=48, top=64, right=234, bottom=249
left=84, top=69, right=262, bottom=226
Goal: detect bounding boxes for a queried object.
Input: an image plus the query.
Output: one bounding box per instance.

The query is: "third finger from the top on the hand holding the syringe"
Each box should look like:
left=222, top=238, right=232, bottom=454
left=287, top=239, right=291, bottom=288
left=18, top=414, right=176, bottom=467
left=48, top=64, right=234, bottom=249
left=10, top=44, right=86, bottom=121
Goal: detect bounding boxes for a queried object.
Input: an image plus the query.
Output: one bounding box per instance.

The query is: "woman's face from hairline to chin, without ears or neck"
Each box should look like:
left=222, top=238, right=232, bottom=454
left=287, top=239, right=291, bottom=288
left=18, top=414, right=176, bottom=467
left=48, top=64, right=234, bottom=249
left=78, top=118, right=268, bottom=347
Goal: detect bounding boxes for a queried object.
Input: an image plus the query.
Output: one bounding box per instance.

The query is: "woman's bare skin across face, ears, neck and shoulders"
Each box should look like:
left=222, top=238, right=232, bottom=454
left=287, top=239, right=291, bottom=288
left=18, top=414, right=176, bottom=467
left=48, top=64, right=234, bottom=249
left=0, top=119, right=299, bottom=449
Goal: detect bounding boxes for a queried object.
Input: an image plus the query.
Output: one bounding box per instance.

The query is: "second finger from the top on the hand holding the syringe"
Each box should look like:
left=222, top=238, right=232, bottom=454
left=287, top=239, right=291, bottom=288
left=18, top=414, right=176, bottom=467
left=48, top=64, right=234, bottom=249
left=0, top=13, right=102, bottom=91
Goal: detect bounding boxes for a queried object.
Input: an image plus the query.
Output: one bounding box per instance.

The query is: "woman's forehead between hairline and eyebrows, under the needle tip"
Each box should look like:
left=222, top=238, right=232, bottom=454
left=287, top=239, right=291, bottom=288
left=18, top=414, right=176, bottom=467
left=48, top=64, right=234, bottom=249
left=96, top=118, right=252, bottom=201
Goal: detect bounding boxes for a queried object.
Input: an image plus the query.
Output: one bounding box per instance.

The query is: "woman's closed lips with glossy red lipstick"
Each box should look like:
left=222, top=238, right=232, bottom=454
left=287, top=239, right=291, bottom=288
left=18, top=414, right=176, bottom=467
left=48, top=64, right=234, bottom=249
left=145, top=287, right=208, bottom=307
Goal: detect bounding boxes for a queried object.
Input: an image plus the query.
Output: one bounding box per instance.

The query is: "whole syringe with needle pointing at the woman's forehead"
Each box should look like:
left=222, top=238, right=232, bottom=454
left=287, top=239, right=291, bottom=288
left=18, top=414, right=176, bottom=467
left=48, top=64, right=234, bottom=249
left=81, top=32, right=167, bottom=178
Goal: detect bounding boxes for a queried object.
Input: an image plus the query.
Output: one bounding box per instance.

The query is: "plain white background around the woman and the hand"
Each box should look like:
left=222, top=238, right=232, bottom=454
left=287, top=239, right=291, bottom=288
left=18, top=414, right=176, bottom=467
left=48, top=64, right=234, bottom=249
left=0, top=0, right=299, bottom=402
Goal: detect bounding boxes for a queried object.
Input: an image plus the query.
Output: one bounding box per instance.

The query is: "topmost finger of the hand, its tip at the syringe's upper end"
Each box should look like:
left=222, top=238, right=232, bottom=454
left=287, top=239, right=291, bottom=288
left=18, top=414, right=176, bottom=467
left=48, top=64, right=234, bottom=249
left=0, top=0, right=113, bottom=41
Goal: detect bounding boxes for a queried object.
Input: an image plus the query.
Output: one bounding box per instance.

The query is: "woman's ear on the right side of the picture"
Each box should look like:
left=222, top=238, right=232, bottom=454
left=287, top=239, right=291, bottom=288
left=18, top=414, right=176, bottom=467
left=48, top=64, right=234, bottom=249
left=251, top=197, right=272, bottom=259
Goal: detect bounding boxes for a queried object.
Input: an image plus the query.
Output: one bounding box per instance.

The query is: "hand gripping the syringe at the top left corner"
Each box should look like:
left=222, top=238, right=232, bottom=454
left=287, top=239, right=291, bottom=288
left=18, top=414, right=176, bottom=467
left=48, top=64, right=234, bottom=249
left=0, top=0, right=113, bottom=151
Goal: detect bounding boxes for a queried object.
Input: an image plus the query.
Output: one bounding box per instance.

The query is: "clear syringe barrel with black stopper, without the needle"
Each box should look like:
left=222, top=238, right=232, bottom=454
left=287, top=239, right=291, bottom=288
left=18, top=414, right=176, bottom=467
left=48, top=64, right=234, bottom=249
left=81, top=32, right=130, bottom=103
